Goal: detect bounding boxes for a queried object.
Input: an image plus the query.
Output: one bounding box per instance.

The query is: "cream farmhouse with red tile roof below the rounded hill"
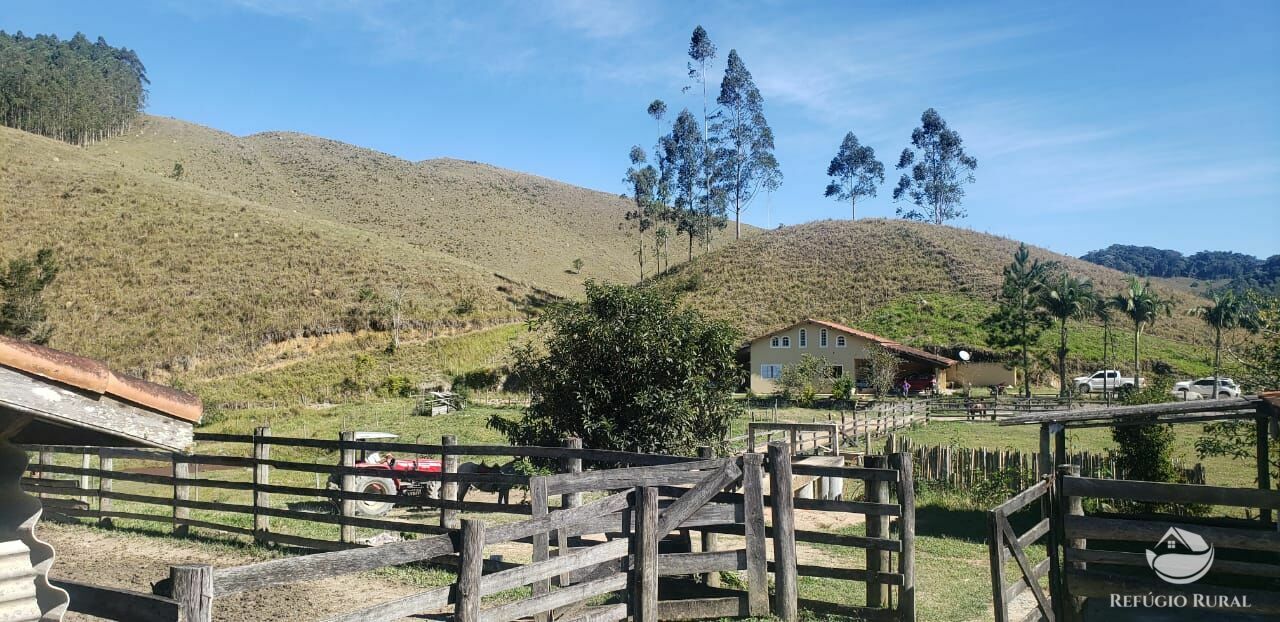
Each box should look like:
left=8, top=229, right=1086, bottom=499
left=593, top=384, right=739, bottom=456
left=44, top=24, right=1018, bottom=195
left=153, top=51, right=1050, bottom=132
left=750, top=320, right=956, bottom=393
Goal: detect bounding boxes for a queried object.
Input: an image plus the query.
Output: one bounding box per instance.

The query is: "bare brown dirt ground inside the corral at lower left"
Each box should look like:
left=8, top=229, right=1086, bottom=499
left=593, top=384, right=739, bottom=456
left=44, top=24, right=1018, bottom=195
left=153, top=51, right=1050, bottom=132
left=38, top=522, right=421, bottom=622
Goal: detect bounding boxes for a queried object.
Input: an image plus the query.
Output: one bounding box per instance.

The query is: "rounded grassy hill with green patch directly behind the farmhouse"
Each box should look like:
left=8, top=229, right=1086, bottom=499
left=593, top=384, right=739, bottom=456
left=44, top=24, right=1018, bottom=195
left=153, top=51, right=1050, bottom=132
left=654, top=219, right=1207, bottom=372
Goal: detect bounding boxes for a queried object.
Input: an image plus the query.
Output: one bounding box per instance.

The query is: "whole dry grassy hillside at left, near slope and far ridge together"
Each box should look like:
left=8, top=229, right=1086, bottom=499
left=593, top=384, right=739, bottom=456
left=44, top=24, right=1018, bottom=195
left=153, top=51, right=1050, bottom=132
left=0, top=116, right=742, bottom=380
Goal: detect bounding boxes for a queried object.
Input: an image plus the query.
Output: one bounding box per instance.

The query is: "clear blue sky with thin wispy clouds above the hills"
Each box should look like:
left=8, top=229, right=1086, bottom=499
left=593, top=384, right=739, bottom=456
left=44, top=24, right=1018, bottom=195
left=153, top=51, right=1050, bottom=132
left=10, top=0, right=1280, bottom=256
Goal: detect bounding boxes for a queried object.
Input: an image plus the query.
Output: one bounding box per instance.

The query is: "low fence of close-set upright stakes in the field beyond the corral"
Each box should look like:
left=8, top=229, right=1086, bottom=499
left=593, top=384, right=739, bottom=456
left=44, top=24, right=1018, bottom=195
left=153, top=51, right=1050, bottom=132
left=887, top=438, right=1206, bottom=490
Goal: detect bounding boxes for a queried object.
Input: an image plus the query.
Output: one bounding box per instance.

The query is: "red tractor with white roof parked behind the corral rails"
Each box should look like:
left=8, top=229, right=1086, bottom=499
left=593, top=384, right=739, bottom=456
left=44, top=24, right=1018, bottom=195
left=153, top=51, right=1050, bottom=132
left=329, top=433, right=444, bottom=516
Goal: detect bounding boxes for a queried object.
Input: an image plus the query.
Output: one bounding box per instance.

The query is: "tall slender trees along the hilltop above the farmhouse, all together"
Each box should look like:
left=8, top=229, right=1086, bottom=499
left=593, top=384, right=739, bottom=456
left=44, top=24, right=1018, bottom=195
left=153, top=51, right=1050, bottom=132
left=622, top=26, right=978, bottom=279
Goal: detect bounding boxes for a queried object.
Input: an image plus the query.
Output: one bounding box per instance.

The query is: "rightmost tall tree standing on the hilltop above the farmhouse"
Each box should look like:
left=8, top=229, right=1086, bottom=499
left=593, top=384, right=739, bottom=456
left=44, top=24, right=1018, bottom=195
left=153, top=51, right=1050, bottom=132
left=893, top=108, right=978, bottom=224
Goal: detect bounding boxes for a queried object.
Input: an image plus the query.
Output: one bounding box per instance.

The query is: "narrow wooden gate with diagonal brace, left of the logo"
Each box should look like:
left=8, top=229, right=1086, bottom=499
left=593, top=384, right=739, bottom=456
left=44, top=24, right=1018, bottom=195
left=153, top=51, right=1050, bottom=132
left=987, top=477, right=1057, bottom=622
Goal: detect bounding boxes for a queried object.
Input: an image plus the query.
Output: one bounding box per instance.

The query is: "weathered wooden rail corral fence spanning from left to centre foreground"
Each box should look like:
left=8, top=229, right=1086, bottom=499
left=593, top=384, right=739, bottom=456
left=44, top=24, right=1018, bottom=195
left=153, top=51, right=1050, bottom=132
left=23, top=430, right=915, bottom=622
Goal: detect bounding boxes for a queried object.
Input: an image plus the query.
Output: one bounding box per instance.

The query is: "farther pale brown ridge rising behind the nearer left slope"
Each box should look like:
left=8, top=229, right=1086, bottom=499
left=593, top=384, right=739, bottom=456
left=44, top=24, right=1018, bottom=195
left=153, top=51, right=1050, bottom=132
left=88, top=116, right=742, bottom=296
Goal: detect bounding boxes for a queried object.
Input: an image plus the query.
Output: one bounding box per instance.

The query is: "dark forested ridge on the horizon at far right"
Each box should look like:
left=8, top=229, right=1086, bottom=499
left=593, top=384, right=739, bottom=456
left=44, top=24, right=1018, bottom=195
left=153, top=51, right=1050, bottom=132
left=1080, top=244, right=1280, bottom=289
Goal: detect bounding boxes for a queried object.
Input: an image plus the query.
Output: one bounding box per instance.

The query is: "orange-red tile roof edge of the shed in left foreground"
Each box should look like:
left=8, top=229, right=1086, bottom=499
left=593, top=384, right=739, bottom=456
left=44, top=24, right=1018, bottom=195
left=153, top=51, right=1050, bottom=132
left=0, top=337, right=204, bottom=422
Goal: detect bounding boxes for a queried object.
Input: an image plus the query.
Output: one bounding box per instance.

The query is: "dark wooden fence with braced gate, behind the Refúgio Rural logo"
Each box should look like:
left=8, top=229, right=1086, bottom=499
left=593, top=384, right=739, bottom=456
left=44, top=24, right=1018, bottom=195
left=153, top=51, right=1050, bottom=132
left=988, top=465, right=1280, bottom=622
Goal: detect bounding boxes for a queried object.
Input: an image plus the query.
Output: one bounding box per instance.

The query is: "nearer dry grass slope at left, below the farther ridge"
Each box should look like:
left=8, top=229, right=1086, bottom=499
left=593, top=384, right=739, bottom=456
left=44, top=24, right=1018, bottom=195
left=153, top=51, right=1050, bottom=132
left=0, top=123, right=529, bottom=372
